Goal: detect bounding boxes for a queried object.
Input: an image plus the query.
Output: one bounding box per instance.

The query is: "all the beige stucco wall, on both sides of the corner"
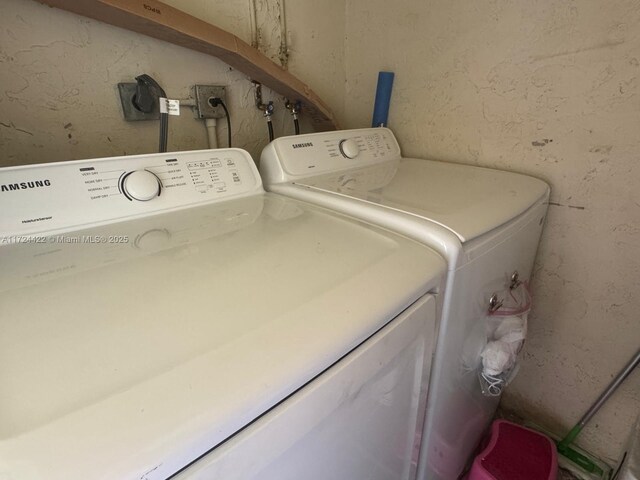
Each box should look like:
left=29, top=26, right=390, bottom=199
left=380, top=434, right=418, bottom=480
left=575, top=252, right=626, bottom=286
left=0, top=0, right=640, bottom=468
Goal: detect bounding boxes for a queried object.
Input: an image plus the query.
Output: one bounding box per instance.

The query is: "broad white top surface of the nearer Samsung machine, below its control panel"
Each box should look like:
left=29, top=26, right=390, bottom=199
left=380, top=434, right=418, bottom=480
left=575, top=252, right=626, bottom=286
left=0, top=194, right=444, bottom=480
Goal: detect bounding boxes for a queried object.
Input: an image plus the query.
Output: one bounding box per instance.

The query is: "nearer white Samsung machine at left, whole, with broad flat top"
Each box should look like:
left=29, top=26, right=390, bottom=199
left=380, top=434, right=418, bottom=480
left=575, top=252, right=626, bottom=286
left=0, top=149, right=445, bottom=480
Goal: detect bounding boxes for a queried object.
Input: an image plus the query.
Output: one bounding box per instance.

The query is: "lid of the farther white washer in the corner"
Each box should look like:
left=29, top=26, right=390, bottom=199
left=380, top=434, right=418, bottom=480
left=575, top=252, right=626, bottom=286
left=296, top=158, right=549, bottom=242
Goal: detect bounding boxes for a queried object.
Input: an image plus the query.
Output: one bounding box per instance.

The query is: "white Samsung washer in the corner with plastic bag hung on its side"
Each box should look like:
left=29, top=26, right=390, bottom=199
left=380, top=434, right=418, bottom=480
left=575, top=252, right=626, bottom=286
left=260, top=128, right=549, bottom=480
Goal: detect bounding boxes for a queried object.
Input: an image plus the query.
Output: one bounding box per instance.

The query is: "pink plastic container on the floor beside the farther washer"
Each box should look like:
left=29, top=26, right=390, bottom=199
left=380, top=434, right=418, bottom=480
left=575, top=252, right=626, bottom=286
left=468, top=420, right=558, bottom=480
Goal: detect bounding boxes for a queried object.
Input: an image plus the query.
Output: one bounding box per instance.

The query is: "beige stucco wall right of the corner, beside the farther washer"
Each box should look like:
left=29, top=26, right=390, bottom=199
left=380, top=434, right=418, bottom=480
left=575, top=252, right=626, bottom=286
left=345, top=0, right=640, bottom=457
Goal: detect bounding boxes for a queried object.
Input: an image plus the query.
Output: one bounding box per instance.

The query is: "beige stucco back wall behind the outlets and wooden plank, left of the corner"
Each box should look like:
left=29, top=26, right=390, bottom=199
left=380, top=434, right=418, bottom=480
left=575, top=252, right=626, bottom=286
left=0, top=0, right=344, bottom=166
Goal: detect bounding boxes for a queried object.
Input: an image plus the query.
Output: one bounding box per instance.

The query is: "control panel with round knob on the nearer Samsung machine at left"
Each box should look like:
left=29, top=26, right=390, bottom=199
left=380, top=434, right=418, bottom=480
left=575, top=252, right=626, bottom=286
left=0, top=149, right=263, bottom=235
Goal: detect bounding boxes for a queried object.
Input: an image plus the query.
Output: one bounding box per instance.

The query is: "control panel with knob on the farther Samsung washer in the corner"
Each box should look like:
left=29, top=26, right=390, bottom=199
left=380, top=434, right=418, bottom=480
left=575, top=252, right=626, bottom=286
left=260, top=128, right=400, bottom=183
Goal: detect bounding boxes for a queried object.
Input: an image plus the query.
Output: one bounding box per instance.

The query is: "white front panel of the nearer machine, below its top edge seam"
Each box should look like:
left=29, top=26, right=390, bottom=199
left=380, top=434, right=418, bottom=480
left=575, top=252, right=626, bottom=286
left=173, top=295, right=436, bottom=480
